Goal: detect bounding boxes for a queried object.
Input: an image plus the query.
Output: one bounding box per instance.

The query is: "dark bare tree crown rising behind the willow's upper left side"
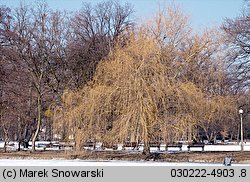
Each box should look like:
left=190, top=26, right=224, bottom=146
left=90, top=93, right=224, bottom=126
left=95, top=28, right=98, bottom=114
left=65, top=1, right=133, bottom=88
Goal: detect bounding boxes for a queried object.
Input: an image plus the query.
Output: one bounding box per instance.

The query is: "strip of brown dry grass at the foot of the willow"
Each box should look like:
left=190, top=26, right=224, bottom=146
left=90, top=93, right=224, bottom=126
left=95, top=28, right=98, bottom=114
left=0, top=151, right=250, bottom=164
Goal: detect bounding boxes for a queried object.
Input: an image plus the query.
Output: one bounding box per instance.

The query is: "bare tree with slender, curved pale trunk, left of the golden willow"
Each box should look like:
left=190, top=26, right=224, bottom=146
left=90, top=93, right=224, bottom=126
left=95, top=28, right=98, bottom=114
left=1, top=2, right=69, bottom=150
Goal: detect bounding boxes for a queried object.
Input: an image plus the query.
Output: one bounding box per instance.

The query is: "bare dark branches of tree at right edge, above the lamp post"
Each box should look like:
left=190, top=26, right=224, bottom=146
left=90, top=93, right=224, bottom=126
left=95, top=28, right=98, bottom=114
left=222, top=1, right=250, bottom=88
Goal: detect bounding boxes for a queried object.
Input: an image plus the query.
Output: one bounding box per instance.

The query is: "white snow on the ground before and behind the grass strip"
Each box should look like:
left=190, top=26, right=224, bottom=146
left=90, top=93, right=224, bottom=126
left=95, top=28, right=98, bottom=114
left=0, top=142, right=250, bottom=166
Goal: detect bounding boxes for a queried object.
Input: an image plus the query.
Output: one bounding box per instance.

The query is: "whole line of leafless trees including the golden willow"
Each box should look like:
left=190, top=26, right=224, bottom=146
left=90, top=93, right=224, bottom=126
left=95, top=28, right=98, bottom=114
left=0, top=1, right=250, bottom=154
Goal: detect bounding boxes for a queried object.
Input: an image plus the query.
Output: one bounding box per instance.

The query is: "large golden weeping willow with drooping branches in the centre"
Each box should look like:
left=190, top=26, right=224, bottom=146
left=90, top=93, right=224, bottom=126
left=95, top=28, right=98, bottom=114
left=52, top=29, right=211, bottom=154
